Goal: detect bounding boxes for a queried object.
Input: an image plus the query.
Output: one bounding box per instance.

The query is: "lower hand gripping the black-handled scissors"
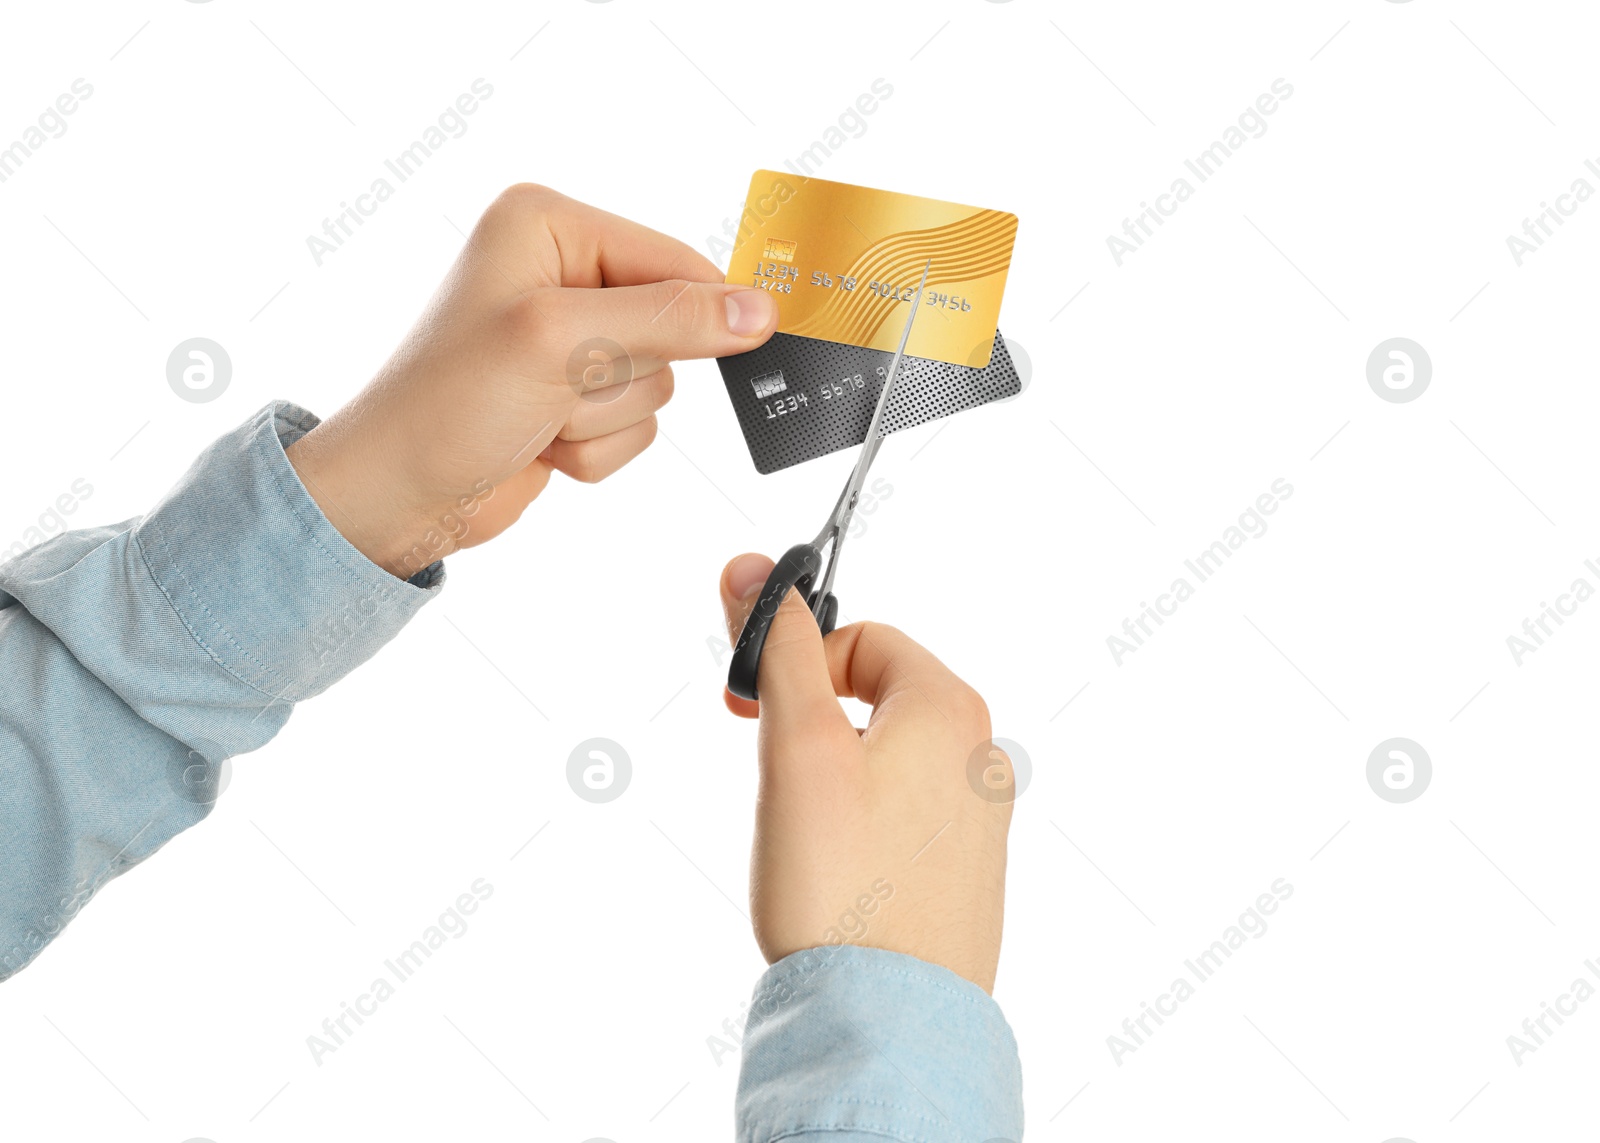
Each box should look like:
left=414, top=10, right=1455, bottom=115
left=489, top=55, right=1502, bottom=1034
left=722, top=555, right=1014, bottom=991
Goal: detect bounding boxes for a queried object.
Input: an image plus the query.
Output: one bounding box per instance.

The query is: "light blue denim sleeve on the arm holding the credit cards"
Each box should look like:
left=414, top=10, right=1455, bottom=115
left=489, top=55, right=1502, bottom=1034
left=0, top=402, right=445, bottom=980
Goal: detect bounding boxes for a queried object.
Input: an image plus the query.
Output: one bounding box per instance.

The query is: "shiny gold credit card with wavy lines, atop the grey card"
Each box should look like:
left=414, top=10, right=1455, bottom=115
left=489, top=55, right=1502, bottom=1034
left=728, top=171, right=1016, bottom=368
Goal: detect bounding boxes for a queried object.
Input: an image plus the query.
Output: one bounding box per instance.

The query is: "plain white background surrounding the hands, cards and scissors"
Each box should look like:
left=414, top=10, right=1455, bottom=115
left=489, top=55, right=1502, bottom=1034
left=0, top=0, right=1600, bottom=1143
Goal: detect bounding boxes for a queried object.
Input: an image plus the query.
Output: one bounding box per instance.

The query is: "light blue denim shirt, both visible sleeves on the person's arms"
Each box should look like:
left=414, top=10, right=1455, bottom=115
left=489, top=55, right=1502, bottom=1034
left=0, top=402, right=1022, bottom=1143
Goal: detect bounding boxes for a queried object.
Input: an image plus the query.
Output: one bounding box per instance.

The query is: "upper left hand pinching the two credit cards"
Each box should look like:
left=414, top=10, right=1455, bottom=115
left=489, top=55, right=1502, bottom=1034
left=288, top=186, right=778, bottom=578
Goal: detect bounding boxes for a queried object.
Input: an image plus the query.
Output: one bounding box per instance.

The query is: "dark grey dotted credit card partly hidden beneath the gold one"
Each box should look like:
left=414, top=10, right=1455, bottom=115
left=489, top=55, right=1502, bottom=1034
left=717, top=333, right=1022, bottom=475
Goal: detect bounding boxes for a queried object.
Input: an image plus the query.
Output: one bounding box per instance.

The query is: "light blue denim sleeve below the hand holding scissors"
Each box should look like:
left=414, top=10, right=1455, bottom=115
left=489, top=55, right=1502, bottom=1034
left=734, top=946, right=1022, bottom=1143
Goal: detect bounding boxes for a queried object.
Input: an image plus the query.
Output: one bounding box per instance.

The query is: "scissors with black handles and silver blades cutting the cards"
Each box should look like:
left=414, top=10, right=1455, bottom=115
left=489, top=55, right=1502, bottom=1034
left=728, top=259, right=933, bottom=700
